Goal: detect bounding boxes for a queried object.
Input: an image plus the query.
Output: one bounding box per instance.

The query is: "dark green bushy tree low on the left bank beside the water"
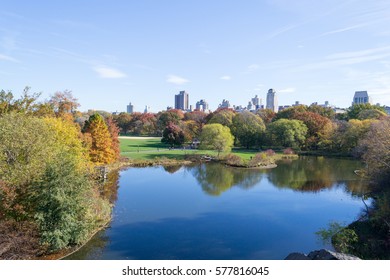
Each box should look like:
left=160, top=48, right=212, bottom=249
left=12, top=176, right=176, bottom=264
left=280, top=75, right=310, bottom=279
left=31, top=154, right=91, bottom=251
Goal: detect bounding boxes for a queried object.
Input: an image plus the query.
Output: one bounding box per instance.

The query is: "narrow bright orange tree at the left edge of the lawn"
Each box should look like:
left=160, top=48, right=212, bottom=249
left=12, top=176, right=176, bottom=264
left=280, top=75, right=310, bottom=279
left=84, top=113, right=115, bottom=164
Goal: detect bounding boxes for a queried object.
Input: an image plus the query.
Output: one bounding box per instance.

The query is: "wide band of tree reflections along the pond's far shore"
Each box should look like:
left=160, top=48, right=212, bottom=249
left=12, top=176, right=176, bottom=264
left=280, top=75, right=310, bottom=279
left=186, top=157, right=368, bottom=196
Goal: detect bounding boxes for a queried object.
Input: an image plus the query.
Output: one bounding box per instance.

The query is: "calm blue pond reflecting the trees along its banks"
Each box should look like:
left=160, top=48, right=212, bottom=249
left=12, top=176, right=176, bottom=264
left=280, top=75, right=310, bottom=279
left=67, top=157, right=368, bottom=260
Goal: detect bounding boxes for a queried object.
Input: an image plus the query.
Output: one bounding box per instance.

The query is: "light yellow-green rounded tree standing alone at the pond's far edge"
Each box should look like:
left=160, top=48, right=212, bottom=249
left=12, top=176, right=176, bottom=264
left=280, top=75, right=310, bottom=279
left=199, top=123, right=234, bottom=156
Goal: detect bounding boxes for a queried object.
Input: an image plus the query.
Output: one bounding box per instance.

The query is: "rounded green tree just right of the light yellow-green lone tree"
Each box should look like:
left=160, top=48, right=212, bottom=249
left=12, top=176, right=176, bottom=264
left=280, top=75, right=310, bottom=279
left=232, top=111, right=265, bottom=149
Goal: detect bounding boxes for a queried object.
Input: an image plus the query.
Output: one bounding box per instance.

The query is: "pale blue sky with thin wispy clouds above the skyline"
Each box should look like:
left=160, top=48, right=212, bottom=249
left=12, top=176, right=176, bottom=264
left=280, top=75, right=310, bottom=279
left=0, top=0, right=390, bottom=112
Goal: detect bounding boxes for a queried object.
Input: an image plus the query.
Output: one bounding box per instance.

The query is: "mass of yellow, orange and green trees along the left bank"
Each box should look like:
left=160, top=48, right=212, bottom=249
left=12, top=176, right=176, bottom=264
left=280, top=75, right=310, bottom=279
left=0, top=88, right=119, bottom=259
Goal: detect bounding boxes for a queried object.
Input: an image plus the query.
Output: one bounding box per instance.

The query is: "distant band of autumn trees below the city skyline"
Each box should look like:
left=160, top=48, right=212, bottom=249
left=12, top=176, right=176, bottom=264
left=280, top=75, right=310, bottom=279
left=113, top=104, right=387, bottom=155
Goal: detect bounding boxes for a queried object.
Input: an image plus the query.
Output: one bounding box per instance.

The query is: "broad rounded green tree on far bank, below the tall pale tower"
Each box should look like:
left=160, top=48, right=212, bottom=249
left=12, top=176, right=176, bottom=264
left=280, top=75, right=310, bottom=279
left=267, top=119, right=307, bottom=148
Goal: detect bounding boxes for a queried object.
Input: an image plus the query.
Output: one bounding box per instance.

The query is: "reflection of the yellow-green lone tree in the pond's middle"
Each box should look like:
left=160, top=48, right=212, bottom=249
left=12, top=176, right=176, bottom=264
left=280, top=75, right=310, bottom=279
left=187, top=163, right=264, bottom=196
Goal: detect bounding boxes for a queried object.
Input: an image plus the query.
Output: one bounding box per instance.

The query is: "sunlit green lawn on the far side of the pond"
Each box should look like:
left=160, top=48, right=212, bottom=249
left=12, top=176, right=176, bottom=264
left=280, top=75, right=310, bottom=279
left=120, top=137, right=292, bottom=160
